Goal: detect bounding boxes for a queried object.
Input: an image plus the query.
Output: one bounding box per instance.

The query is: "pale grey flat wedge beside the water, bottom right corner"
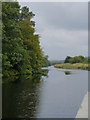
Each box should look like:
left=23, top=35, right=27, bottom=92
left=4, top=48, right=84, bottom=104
left=76, top=92, right=88, bottom=118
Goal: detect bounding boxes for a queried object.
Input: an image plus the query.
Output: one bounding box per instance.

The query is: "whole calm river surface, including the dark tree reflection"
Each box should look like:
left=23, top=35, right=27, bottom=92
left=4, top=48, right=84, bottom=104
left=3, top=66, right=88, bottom=118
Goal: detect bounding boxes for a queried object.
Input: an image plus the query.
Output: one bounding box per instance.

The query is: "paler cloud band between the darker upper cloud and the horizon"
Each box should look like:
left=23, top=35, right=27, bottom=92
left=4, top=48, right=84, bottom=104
left=41, top=30, right=88, bottom=59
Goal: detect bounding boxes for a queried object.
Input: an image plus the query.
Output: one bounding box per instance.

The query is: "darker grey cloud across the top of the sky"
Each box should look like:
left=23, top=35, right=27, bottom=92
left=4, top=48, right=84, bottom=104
left=31, top=2, right=88, bottom=30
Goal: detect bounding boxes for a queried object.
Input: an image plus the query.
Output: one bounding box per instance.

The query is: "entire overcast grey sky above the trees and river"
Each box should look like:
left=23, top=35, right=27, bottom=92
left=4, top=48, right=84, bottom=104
left=20, top=2, right=88, bottom=60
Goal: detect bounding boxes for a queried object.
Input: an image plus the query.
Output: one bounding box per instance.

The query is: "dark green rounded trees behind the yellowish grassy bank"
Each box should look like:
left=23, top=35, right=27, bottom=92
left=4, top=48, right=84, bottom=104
left=64, top=56, right=88, bottom=64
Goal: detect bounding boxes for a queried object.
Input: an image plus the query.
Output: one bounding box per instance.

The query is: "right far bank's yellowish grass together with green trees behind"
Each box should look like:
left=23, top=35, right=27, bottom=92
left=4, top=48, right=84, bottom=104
left=54, top=56, right=89, bottom=70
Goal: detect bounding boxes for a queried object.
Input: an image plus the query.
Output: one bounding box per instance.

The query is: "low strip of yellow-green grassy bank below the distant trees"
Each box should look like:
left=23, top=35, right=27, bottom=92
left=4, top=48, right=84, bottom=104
left=54, top=63, right=88, bottom=70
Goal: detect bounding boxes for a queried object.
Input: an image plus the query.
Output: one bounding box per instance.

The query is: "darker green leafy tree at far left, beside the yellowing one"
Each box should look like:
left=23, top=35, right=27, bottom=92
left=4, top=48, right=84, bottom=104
left=2, top=2, right=23, bottom=75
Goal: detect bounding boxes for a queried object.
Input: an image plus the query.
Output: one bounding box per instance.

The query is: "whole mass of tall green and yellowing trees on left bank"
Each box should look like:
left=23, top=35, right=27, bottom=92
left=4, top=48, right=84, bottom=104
left=2, top=2, right=48, bottom=79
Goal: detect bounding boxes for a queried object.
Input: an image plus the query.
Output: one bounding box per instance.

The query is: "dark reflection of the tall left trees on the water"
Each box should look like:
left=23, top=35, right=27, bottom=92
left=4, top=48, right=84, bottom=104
left=2, top=75, right=44, bottom=118
